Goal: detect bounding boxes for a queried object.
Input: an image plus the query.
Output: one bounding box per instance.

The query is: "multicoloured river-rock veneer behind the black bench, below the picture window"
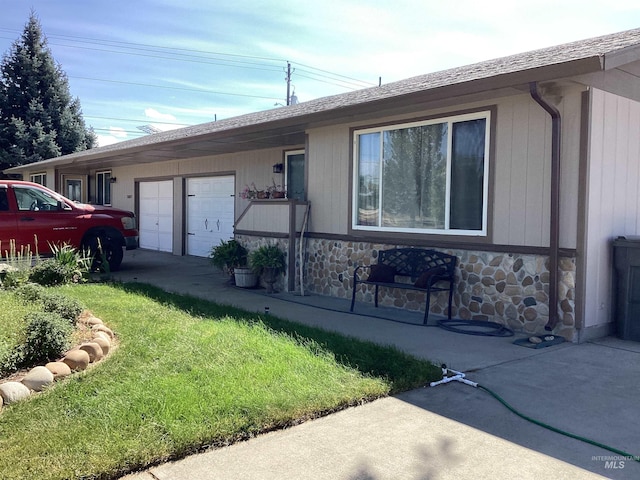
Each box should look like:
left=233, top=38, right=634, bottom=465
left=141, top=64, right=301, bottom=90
left=305, top=239, right=575, bottom=340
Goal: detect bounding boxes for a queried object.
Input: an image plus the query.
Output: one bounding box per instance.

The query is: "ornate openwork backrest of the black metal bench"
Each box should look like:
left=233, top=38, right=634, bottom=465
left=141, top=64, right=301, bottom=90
left=378, top=248, right=457, bottom=281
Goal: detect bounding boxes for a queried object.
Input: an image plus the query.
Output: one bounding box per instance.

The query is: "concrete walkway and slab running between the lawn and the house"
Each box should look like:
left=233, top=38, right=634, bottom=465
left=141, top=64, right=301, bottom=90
left=114, top=250, right=640, bottom=480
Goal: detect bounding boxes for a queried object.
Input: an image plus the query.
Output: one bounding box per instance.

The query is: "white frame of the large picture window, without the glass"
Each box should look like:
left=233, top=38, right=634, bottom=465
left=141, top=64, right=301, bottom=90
left=350, top=107, right=496, bottom=236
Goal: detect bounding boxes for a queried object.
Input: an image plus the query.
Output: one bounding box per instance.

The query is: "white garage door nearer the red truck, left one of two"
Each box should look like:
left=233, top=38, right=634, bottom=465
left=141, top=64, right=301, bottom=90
left=139, top=180, right=173, bottom=252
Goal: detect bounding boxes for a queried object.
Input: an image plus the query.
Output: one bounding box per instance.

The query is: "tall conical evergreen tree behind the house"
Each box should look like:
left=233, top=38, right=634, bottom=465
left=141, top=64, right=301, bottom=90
left=0, top=12, right=96, bottom=166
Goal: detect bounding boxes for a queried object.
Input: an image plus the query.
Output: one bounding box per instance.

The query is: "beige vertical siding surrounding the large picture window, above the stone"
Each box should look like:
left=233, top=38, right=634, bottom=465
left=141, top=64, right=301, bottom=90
left=307, top=87, right=583, bottom=249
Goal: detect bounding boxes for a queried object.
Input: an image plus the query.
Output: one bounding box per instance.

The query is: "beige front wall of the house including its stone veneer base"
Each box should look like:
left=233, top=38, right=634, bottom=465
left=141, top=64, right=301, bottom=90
left=16, top=87, right=584, bottom=339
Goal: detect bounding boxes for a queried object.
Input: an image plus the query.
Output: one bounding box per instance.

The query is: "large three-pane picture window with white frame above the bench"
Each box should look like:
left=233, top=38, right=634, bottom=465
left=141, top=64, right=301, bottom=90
left=353, top=112, right=490, bottom=236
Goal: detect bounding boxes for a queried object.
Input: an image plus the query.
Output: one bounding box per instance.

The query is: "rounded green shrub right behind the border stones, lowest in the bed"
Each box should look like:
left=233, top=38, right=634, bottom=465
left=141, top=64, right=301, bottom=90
left=21, top=312, right=73, bottom=364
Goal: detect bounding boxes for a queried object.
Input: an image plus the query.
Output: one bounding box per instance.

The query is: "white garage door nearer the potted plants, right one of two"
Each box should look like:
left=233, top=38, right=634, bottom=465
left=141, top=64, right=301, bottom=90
left=187, top=176, right=235, bottom=257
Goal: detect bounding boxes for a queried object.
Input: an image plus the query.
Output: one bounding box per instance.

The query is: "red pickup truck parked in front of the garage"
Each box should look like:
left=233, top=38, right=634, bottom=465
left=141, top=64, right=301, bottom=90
left=0, top=180, right=138, bottom=270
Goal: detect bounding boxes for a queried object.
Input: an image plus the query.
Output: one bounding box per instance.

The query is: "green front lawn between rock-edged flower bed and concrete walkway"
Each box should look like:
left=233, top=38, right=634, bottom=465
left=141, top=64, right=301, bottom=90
left=0, top=284, right=440, bottom=479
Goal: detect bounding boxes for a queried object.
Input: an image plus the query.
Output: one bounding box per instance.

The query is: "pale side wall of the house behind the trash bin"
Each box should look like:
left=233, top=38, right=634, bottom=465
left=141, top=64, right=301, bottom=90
left=584, top=89, right=640, bottom=328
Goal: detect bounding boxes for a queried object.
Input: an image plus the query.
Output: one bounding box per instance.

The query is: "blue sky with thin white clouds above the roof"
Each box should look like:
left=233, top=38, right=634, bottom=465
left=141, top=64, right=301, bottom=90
left=0, top=0, right=640, bottom=145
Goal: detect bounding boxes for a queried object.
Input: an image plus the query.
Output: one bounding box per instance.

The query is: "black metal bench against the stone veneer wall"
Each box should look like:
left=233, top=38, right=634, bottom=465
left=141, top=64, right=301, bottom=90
left=350, top=248, right=458, bottom=325
